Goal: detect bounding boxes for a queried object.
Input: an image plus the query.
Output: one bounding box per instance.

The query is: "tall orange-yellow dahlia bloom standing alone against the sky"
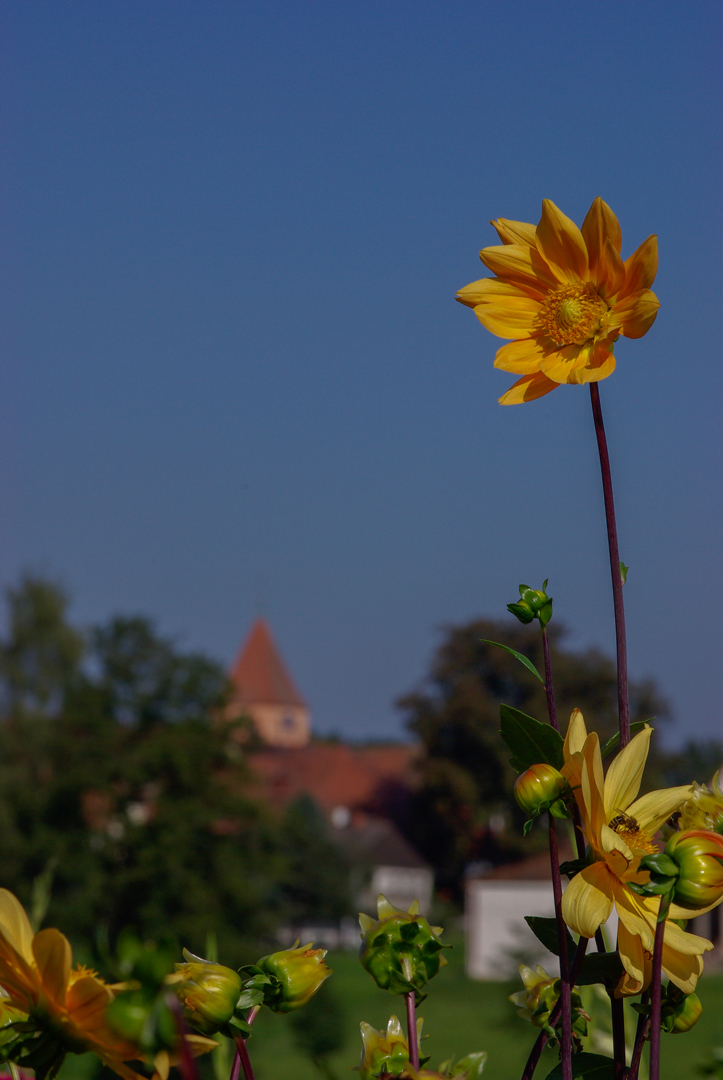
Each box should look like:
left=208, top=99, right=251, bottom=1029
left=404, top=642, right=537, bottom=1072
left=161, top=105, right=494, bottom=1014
left=457, top=198, right=659, bottom=405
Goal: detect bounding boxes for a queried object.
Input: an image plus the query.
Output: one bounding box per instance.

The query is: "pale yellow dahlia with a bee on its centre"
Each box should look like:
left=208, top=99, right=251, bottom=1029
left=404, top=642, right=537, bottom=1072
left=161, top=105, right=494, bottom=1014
left=562, top=710, right=713, bottom=995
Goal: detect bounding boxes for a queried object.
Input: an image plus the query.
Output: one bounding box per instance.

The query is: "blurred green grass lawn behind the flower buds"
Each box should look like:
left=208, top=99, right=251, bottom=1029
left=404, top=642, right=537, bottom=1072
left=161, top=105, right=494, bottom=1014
left=249, top=943, right=723, bottom=1080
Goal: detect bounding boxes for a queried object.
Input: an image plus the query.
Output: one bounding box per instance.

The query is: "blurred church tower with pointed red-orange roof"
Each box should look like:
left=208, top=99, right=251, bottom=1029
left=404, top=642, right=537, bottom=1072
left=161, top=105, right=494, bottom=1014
left=226, top=619, right=311, bottom=747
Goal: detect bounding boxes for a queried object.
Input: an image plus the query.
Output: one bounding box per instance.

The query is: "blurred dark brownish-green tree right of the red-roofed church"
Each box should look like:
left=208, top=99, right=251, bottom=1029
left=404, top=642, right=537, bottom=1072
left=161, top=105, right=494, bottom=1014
left=398, top=619, right=668, bottom=890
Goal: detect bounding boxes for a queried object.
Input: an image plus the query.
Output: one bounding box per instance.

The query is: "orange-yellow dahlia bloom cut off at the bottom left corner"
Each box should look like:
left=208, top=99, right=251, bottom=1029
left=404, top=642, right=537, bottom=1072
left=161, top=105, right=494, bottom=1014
left=0, top=889, right=143, bottom=1080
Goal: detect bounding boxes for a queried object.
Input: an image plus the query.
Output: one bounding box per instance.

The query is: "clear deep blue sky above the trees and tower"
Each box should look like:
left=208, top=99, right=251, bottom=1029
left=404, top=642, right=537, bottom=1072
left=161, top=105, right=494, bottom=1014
left=0, top=0, right=723, bottom=738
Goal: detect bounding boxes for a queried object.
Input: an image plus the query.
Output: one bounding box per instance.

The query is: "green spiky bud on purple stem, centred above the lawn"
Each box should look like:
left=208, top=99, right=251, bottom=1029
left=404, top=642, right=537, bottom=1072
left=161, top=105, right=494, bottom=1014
left=359, top=895, right=446, bottom=1001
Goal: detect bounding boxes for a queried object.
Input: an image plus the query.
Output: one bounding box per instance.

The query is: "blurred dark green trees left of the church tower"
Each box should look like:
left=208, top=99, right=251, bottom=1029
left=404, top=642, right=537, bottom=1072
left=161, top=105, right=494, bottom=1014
left=0, top=579, right=337, bottom=964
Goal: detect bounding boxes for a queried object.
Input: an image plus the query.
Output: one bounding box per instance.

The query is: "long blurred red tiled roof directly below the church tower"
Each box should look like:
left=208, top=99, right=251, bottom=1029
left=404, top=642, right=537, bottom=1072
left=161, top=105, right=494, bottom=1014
left=250, top=743, right=417, bottom=812
